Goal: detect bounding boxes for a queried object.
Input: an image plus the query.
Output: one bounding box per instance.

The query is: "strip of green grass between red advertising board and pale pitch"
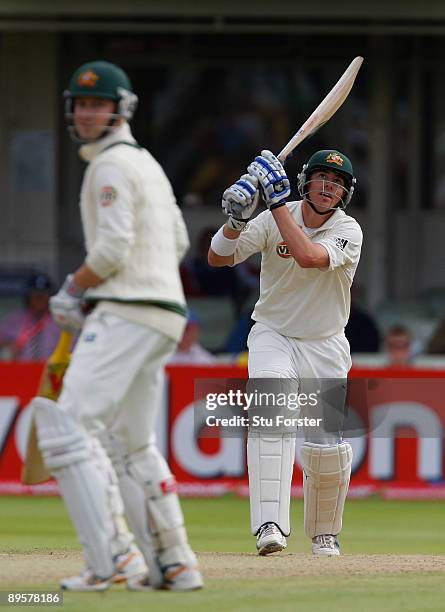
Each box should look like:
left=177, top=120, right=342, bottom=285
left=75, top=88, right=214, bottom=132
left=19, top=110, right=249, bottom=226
left=0, top=496, right=445, bottom=554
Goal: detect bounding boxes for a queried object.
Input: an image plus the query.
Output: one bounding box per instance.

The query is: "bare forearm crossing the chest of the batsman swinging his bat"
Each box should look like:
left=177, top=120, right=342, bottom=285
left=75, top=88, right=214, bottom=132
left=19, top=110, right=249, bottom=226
left=272, top=206, right=329, bottom=268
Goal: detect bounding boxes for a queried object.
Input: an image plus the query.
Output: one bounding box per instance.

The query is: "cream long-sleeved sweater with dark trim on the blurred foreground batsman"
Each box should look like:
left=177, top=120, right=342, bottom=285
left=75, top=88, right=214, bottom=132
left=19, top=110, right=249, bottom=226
left=80, top=123, right=189, bottom=341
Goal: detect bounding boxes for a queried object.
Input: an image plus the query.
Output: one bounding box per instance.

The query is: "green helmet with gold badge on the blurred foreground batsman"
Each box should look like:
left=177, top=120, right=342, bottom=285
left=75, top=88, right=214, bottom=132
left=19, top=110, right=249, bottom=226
left=64, top=61, right=138, bottom=121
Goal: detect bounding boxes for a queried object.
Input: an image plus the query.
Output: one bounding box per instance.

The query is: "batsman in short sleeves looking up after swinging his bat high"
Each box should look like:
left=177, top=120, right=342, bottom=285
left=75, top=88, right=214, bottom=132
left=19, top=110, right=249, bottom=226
left=208, top=150, right=362, bottom=556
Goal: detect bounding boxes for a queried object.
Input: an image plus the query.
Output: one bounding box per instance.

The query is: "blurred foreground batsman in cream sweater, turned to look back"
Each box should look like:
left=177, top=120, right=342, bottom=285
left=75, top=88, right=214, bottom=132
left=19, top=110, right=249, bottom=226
left=34, top=61, right=202, bottom=591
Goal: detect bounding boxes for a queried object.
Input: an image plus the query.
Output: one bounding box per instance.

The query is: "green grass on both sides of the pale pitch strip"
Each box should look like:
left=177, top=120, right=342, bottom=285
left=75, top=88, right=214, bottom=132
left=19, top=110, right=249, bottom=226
left=0, top=497, right=445, bottom=612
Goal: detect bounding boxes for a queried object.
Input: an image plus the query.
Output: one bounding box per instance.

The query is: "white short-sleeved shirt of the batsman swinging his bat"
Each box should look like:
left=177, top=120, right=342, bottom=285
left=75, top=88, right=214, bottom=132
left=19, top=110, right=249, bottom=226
left=234, top=201, right=363, bottom=339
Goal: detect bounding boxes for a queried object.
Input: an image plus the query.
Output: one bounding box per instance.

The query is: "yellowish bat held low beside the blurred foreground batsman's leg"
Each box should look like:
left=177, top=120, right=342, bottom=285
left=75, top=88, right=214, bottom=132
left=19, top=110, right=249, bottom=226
left=22, top=331, right=72, bottom=485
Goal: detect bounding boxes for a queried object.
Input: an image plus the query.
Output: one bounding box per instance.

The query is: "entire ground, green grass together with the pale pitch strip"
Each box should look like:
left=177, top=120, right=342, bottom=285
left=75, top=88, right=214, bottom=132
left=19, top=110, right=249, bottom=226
left=0, top=497, right=445, bottom=612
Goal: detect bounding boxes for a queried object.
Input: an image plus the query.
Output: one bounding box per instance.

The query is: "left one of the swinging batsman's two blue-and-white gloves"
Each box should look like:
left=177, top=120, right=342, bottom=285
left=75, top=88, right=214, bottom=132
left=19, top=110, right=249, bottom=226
left=221, top=174, right=259, bottom=231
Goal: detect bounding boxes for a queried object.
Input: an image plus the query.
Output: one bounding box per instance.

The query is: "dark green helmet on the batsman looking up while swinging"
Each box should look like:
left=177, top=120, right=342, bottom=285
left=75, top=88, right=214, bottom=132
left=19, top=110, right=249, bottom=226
left=297, top=149, right=357, bottom=208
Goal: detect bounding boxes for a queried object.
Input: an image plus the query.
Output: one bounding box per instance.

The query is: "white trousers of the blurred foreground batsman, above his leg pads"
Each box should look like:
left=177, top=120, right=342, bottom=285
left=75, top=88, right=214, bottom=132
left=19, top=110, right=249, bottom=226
left=58, top=312, right=176, bottom=454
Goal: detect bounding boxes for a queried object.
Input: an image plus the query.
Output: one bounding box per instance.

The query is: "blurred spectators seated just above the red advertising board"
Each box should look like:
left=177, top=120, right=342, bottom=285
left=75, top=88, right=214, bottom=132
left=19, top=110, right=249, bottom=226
left=0, top=260, right=445, bottom=368
